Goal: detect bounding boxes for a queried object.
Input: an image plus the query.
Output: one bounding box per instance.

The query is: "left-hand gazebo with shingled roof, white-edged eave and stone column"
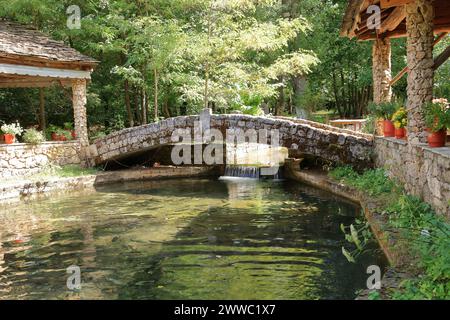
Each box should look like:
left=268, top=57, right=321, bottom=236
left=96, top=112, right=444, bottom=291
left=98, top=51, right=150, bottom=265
left=0, top=19, right=97, bottom=146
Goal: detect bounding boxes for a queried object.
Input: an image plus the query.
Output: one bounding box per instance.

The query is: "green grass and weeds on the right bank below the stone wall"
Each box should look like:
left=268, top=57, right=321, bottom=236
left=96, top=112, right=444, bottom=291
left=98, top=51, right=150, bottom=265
left=329, top=167, right=450, bottom=300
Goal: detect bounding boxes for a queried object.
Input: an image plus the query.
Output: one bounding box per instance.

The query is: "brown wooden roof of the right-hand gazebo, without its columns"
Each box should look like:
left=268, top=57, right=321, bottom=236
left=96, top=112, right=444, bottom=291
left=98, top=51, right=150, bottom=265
left=341, top=0, right=450, bottom=40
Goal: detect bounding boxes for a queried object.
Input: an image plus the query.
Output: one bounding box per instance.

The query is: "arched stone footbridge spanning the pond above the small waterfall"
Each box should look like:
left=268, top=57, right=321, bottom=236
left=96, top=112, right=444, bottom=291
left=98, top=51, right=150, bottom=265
left=87, top=111, right=373, bottom=167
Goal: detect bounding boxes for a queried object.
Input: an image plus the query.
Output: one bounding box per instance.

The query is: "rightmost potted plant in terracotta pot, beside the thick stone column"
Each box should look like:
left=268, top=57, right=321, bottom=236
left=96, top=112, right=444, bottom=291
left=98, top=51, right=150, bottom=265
left=423, top=100, right=450, bottom=148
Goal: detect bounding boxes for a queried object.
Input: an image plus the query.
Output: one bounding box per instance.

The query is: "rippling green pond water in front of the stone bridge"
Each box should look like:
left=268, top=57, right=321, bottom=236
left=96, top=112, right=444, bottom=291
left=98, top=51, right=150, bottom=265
left=0, top=180, right=383, bottom=299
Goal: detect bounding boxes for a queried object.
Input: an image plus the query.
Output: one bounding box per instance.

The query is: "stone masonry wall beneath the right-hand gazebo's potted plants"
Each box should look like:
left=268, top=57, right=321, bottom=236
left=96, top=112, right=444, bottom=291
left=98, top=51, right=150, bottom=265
left=375, top=137, right=450, bottom=218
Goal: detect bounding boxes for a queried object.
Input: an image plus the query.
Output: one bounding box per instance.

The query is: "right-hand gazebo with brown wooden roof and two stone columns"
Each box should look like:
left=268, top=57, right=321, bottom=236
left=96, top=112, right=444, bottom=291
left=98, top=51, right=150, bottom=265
left=341, top=0, right=450, bottom=144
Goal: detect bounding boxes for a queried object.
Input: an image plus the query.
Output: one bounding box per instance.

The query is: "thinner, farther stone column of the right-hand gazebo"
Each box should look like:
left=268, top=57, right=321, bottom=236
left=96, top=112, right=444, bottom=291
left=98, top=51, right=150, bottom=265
left=372, top=38, right=392, bottom=103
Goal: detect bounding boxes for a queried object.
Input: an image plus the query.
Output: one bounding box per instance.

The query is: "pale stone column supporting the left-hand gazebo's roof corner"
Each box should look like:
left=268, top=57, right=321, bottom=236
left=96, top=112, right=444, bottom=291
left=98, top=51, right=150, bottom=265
left=72, top=79, right=89, bottom=147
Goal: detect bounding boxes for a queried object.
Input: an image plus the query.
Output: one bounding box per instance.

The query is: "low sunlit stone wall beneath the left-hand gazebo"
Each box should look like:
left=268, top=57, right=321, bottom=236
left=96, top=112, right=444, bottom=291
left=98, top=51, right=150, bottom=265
left=0, top=141, right=81, bottom=178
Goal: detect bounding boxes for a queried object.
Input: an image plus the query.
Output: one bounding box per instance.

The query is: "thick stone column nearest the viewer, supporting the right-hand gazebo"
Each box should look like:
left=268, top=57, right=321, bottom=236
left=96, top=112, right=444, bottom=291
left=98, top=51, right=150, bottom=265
left=406, top=0, right=434, bottom=144
